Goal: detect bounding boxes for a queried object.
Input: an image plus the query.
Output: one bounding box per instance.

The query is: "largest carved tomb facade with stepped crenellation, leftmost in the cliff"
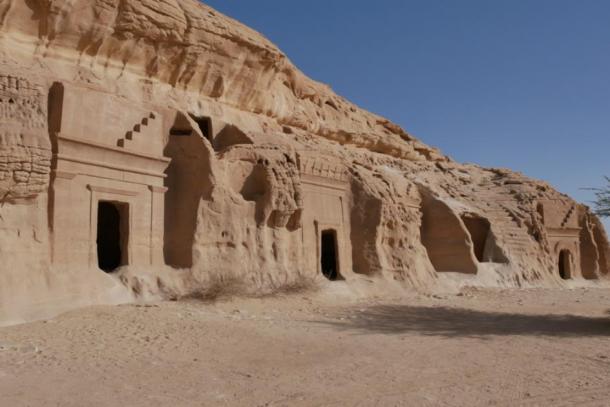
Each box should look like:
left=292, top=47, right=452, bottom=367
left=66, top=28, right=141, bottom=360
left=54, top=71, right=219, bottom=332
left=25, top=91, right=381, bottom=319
left=49, top=84, right=170, bottom=271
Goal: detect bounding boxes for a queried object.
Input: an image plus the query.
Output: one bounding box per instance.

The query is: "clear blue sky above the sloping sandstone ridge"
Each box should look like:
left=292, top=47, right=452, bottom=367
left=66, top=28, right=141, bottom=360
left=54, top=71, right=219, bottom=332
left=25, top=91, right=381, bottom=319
left=204, top=0, right=610, bottom=230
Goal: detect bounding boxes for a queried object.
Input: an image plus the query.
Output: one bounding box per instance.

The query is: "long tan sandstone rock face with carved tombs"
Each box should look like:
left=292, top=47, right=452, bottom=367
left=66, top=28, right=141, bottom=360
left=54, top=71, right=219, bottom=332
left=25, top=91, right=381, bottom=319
left=0, top=0, right=610, bottom=322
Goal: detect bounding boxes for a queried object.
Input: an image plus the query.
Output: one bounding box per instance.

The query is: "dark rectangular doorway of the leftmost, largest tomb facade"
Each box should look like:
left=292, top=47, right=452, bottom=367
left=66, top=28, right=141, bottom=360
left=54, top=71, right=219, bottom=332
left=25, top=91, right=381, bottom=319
left=97, top=201, right=128, bottom=273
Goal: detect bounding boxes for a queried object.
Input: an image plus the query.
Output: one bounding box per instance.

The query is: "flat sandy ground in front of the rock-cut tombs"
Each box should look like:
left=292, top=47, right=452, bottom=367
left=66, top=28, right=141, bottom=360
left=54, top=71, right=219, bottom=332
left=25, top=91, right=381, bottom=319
left=0, top=289, right=610, bottom=407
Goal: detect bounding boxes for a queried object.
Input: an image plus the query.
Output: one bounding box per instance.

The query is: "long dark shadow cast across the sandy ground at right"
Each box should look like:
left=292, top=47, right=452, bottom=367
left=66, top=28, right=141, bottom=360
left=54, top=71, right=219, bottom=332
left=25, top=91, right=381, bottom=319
left=318, top=305, right=610, bottom=337
